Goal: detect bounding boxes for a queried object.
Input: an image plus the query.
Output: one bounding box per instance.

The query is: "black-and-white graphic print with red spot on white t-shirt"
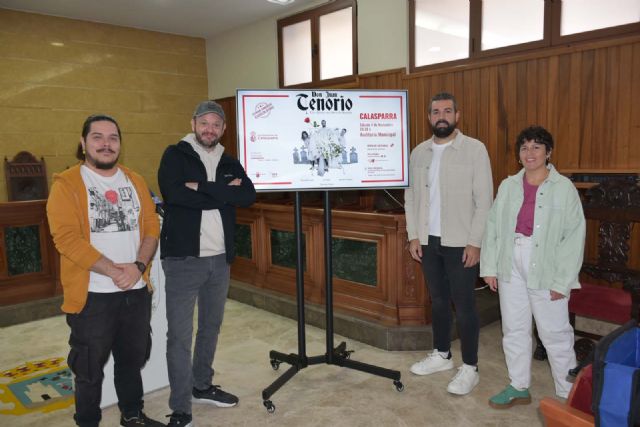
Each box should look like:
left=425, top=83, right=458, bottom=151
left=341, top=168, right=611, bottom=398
left=88, top=186, right=140, bottom=233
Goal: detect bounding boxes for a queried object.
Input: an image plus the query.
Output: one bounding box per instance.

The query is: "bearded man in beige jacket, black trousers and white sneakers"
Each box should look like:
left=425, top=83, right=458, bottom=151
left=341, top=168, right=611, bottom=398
left=405, top=92, right=493, bottom=395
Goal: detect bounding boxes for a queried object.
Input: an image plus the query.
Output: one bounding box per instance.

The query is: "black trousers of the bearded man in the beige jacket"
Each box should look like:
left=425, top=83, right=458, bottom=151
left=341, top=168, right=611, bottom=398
left=422, top=236, right=480, bottom=365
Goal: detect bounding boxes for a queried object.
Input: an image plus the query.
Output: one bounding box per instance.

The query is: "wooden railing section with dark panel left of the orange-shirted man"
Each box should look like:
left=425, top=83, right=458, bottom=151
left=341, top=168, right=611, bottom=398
left=0, top=200, right=62, bottom=306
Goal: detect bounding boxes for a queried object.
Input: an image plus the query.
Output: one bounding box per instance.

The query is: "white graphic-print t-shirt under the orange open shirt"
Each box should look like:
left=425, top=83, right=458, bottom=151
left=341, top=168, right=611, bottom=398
left=80, top=165, right=145, bottom=293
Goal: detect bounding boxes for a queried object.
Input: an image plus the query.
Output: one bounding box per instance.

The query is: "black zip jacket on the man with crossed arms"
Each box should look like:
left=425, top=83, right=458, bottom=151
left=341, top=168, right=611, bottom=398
left=158, top=141, right=256, bottom=263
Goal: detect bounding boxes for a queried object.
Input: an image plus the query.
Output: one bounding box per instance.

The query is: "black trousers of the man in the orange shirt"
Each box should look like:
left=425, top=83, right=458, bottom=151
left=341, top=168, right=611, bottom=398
left=67, top=288, right=151, bottom=427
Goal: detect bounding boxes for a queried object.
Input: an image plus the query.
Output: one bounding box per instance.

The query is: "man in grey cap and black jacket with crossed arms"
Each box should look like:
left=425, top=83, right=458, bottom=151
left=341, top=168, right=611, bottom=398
left=158, top=101, right=256, bottom=427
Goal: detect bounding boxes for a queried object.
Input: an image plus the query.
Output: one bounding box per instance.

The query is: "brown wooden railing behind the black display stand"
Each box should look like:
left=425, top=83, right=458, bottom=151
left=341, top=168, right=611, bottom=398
left=231, top=203, right=431, bottom=325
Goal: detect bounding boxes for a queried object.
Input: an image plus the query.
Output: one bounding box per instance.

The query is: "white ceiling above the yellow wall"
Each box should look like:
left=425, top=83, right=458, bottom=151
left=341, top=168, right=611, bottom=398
left=0, top=0, right=317, bottom=39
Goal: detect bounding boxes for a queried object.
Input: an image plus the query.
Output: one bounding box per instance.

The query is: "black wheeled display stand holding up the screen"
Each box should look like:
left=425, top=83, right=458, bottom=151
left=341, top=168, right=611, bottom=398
left=262, top=191, right=404, bottom=413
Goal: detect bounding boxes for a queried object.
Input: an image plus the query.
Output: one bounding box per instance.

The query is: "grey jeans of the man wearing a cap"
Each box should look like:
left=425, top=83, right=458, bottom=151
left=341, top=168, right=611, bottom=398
left=162, top=254, right=230, bottom=414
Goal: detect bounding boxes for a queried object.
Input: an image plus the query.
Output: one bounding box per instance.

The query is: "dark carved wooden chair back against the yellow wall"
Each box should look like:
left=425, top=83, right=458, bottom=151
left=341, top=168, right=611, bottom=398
left=4, top=151, right=49, bottom=202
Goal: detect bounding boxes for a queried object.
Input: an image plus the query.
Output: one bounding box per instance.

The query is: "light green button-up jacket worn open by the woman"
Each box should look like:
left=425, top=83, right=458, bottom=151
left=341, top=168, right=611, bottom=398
left=480, top=165, right=586, bottom=296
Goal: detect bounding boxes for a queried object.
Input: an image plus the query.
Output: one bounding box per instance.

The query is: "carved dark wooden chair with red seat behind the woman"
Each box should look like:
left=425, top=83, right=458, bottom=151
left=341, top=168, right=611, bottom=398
left=534, top=179, right=640, bottom=360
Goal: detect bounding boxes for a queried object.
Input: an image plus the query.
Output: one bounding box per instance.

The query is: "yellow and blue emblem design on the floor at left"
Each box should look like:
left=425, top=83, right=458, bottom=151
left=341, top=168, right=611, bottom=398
left=0, top=357, right=74, bottom=415
